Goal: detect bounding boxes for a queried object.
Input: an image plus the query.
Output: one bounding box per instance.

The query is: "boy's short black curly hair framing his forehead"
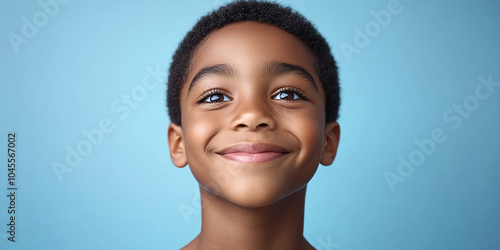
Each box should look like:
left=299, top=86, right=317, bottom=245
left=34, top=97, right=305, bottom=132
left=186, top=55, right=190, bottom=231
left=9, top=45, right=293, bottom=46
left=167, top=0, right=340, bottom=125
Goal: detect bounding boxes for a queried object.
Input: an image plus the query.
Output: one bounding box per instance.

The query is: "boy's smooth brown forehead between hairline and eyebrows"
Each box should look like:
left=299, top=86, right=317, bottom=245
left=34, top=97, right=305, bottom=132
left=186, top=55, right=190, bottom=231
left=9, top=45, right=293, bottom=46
left=188, top=21, right=317, bottom=81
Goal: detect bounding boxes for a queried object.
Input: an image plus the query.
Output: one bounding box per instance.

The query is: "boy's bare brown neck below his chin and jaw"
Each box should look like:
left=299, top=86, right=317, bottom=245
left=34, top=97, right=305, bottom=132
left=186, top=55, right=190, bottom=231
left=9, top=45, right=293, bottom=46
left=186, top=187, right=313, bottom=249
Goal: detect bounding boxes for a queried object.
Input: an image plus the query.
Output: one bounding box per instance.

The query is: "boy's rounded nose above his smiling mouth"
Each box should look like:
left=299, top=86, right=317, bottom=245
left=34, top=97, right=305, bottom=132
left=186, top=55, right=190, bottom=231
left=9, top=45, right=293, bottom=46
left=231, top=95, right=276, bottom=131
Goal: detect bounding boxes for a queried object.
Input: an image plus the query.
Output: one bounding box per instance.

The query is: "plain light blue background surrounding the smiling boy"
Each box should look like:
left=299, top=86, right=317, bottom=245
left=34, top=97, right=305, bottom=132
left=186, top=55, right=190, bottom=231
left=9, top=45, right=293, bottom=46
left=0, top=0, right=500, bottom=250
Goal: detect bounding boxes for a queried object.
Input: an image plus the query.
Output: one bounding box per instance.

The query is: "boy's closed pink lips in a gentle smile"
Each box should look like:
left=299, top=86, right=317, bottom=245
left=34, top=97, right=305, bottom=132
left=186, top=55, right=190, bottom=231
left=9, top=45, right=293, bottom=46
left=217, top=143, right=289, bottom=163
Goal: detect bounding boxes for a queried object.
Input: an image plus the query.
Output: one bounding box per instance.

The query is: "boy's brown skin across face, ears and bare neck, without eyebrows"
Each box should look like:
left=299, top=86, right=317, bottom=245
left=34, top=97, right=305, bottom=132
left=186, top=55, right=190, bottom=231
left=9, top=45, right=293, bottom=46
left=168, top=22, right=340, bottom=249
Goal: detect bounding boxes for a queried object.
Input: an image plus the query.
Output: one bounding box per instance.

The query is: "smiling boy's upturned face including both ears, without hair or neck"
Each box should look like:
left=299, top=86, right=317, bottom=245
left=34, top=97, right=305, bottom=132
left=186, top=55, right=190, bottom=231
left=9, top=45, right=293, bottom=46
left=169, top=22, right=340, bottom=207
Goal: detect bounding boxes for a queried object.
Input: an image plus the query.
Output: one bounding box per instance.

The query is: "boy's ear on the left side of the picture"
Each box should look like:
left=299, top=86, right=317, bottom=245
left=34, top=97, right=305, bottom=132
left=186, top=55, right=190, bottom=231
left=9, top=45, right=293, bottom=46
left=168, top=123, right=187, bottom=168
